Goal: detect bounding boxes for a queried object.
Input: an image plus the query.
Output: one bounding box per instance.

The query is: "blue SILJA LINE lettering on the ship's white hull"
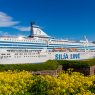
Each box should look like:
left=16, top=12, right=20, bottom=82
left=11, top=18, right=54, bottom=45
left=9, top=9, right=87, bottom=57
left=55, top=53, right=80, bottom=60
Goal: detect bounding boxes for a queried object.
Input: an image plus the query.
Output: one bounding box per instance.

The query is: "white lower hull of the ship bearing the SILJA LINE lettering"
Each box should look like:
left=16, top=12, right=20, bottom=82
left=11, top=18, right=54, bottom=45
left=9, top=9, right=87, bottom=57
left=0, top=49, right=95, bottom=64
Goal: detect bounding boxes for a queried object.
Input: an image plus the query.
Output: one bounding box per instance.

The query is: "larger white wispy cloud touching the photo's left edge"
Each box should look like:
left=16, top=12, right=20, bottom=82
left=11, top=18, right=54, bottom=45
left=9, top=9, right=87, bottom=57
left=0, top=12, right=19, bottom=27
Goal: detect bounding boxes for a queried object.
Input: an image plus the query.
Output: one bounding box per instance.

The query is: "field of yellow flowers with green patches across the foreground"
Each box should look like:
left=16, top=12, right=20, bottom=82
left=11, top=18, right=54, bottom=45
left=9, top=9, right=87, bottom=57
left=0, top=71, right=95, bottom=95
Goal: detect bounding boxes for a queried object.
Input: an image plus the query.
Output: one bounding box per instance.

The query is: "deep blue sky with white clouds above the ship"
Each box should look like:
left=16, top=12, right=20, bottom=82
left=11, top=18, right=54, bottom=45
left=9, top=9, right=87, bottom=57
left=0, top=0, right=95, bottom=40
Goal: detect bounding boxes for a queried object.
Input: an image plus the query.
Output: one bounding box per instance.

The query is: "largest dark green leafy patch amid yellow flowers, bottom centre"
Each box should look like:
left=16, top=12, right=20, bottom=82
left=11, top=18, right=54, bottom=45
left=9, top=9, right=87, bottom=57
left=29, top=76, right=49, bottom=95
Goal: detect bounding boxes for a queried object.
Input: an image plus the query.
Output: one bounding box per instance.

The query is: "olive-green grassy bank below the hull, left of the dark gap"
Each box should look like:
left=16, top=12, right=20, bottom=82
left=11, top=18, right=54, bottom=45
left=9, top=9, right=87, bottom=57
left=0, top=60, right=58, bottom=71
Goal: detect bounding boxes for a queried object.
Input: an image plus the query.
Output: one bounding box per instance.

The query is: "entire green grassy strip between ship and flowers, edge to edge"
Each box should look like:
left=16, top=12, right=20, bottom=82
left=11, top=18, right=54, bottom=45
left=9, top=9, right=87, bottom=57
left=0, top=59, right=95, bottom=71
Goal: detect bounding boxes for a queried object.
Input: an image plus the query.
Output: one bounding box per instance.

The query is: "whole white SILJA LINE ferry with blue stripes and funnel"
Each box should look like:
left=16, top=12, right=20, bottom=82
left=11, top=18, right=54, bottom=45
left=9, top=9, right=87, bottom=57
left=0, top=23, right=95, bottom=64
